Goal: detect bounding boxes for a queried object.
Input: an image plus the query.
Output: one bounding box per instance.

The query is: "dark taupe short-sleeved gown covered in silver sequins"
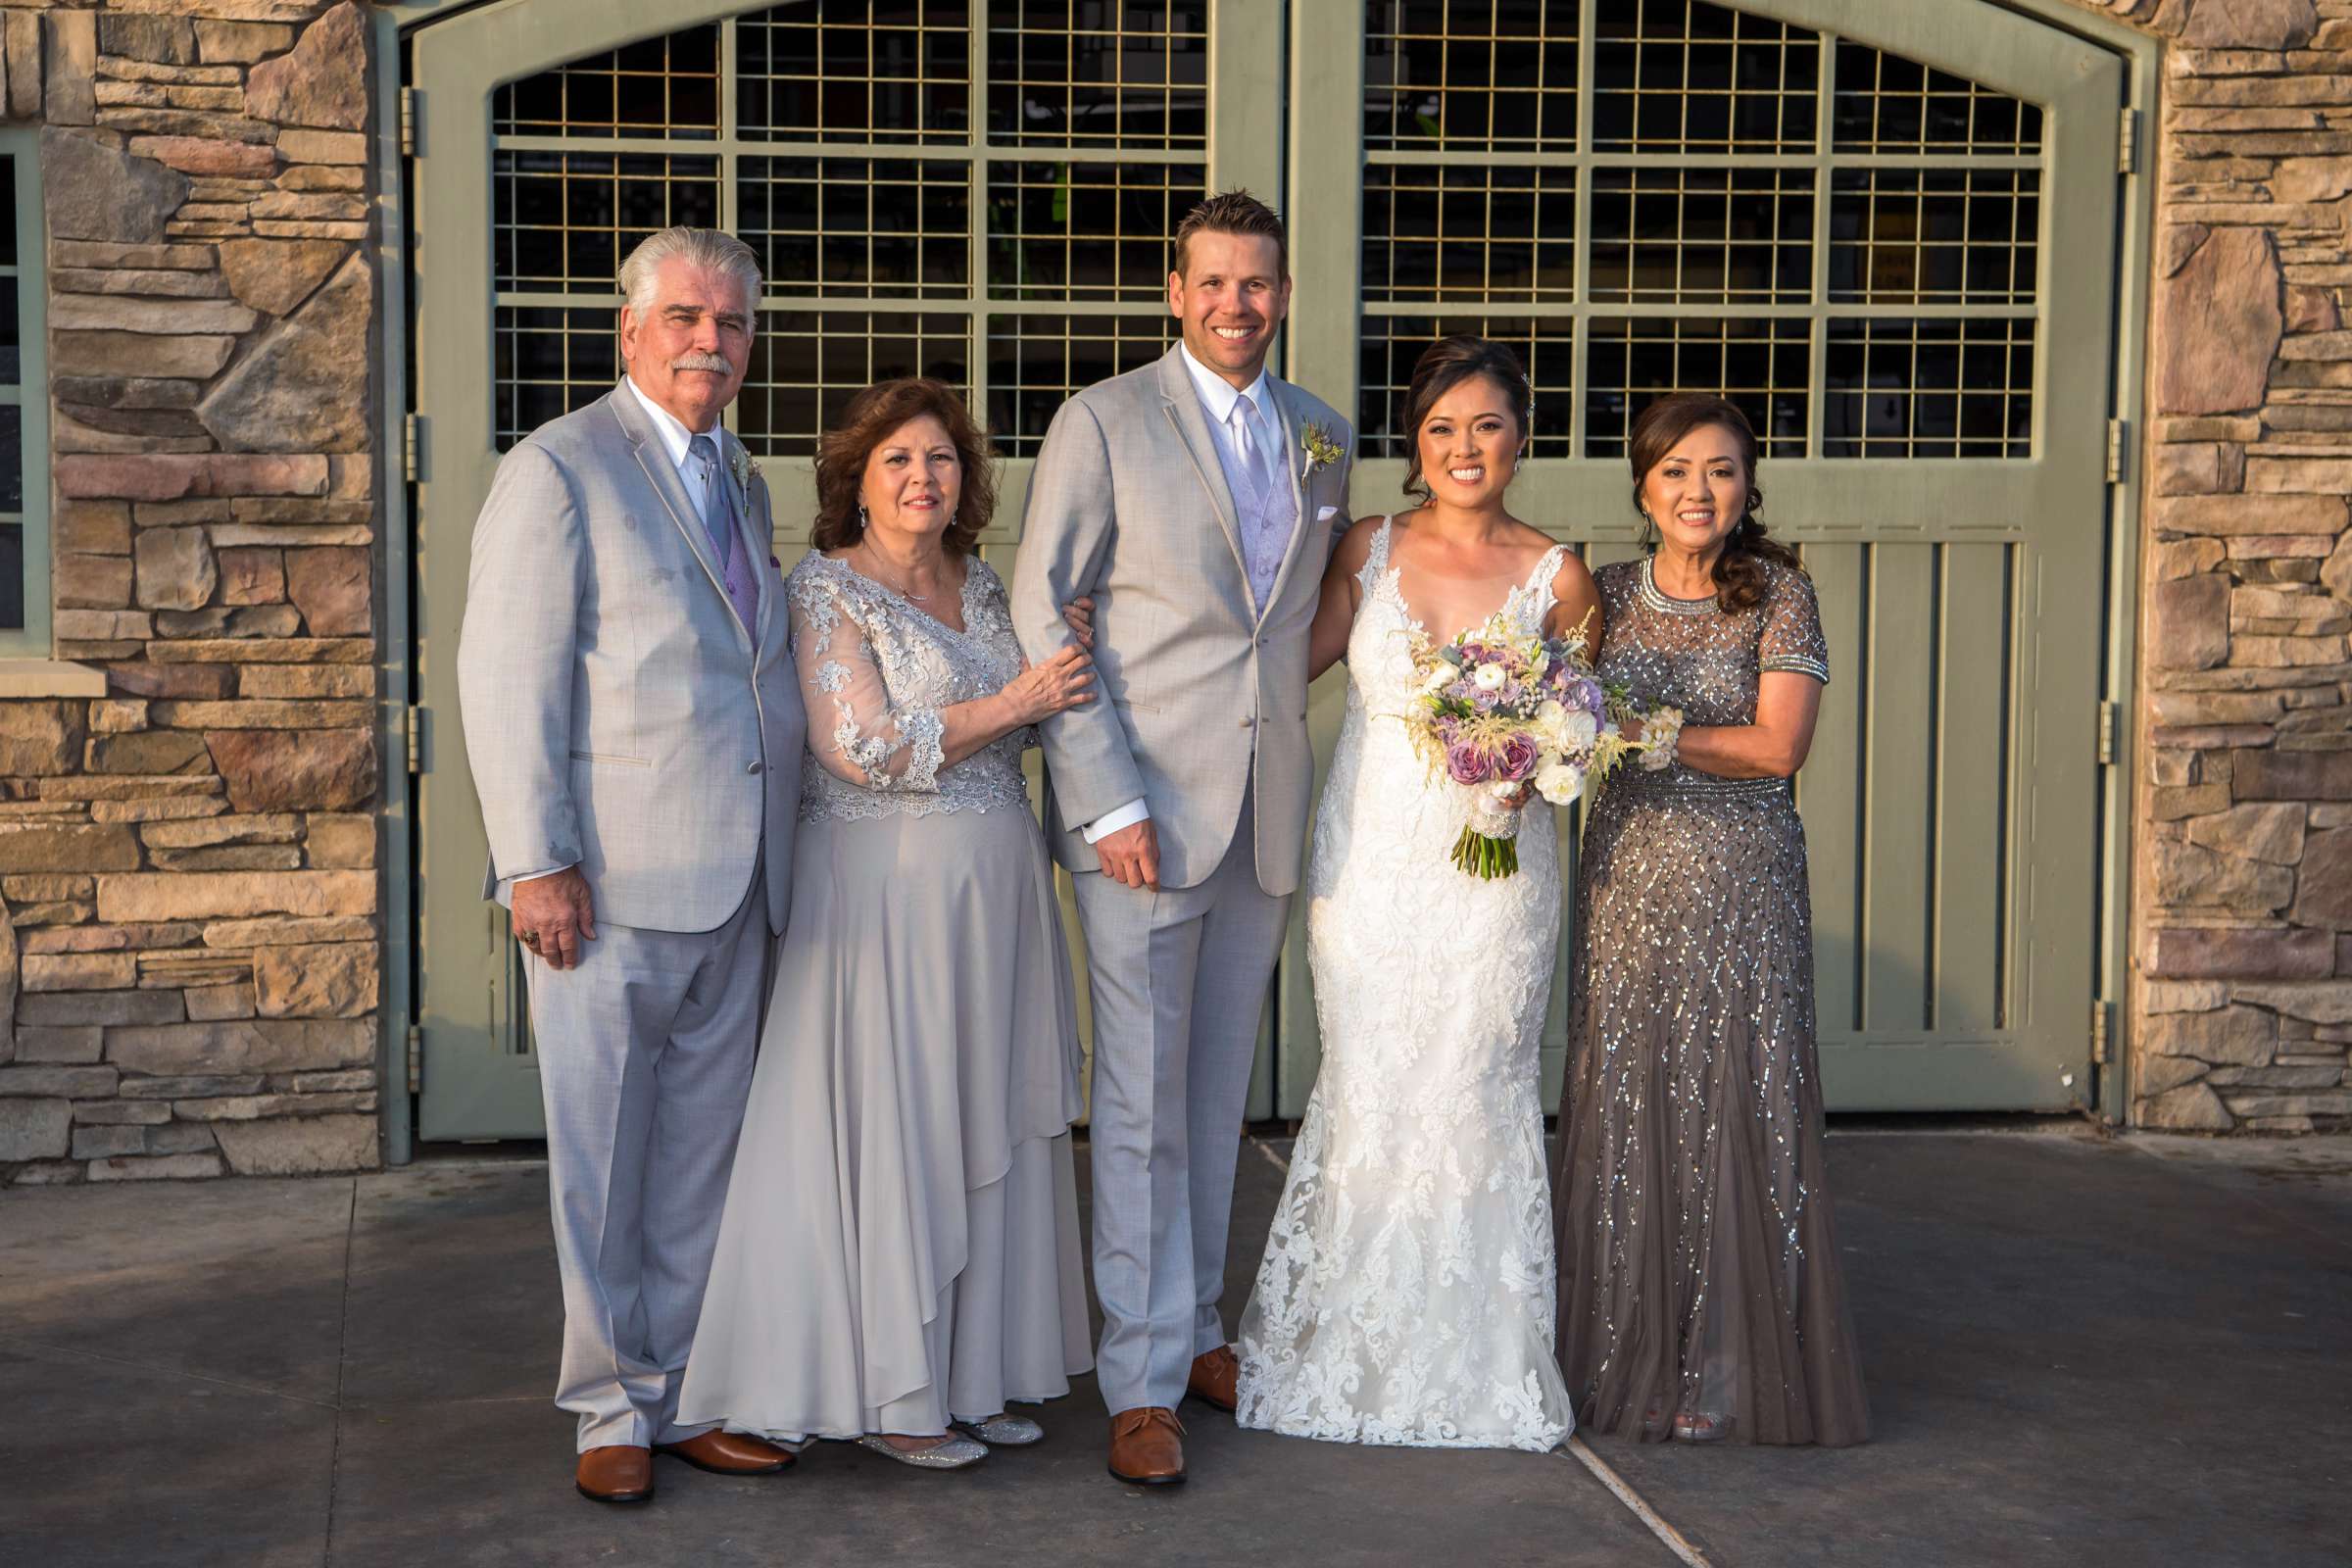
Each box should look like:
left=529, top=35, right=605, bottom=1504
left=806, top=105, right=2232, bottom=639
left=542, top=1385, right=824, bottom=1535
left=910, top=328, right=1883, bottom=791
left=1552, top=560, right=1870, bottom=1446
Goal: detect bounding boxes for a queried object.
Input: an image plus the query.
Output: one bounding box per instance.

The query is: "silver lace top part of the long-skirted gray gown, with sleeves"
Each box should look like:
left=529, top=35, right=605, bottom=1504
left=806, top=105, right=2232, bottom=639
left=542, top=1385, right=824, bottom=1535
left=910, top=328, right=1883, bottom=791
left=783, top=555, right=1037, bottom=823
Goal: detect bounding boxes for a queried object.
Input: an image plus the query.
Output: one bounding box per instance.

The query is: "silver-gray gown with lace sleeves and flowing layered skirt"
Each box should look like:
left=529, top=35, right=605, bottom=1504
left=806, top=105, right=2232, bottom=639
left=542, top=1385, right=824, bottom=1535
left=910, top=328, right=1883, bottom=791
left=680, top=555, right=1094, bottom=1441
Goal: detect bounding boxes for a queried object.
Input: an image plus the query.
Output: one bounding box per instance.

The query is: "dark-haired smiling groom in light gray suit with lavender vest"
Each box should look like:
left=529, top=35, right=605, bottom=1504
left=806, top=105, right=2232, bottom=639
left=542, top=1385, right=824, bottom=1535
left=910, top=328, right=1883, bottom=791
left=1011, top=190, right=1352, bottom=1486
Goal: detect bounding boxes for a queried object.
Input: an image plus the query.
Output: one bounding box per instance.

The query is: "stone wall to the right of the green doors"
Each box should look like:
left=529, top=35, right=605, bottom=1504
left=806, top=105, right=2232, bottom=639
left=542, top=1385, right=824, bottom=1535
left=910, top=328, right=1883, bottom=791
left=2077, top=0, right=2352, bottom=1131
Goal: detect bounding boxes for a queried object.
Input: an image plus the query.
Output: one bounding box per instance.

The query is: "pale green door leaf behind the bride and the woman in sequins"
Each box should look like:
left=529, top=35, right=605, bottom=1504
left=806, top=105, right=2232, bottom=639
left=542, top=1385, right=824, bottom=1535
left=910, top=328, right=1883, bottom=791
left=1277, top=0, right=2122, bottom=1116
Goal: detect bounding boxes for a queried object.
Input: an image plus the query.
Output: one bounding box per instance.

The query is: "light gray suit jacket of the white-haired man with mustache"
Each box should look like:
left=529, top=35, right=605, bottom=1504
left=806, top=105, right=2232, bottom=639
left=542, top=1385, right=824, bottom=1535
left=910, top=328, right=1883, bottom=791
left=459, top=388, right=807, bottom=931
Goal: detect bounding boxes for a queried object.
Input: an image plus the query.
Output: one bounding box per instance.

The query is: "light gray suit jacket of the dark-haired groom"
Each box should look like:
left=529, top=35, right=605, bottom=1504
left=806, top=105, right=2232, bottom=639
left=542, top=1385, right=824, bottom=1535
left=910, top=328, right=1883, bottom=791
left=1011, top=346, right=1354, bottom=896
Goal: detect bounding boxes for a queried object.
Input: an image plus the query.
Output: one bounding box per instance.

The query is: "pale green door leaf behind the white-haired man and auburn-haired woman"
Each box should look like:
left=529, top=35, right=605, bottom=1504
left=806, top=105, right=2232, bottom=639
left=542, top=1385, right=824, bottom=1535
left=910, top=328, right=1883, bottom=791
left=412, top=0, right=1282, bottom=1138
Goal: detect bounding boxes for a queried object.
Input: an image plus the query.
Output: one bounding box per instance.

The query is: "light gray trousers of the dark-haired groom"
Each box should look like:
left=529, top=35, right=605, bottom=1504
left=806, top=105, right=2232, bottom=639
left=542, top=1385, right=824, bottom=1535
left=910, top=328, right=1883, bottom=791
left=1072, top=795, right=1292, bottom=1415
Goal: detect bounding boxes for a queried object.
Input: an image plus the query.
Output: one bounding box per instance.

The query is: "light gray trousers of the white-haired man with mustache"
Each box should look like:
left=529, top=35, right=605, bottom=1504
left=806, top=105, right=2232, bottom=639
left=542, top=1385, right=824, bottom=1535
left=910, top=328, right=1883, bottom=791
left=527, top=872, right=774, bottom=1452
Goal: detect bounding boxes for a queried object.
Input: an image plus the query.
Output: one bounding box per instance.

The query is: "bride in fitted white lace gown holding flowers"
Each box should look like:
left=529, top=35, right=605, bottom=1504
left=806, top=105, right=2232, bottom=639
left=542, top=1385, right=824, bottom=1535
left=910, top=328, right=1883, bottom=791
left=1237, top=338, right=1599, bottom=1452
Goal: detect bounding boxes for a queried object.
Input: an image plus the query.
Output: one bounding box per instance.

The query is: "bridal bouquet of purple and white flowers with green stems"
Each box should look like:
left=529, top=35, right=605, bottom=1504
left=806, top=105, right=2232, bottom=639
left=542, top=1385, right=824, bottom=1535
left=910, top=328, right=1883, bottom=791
left=1413, top=612, right=1680, bottom=879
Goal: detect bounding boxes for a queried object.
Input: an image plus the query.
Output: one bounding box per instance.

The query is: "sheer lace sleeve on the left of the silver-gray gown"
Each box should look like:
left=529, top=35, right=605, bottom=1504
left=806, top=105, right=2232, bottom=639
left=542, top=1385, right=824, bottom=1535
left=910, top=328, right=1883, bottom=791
left=793, top=578, right=946, bottom=795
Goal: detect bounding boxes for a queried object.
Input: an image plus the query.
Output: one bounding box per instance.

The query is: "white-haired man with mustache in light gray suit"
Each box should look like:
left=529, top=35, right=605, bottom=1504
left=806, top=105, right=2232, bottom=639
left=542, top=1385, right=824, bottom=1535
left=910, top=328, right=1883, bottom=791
left=459, top=228, right=805, bottom=1502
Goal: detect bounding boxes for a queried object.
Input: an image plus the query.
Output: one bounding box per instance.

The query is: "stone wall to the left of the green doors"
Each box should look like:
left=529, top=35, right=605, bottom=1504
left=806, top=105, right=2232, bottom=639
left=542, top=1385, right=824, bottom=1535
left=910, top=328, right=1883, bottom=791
left=0, top=0, right=381, bottom=1183
